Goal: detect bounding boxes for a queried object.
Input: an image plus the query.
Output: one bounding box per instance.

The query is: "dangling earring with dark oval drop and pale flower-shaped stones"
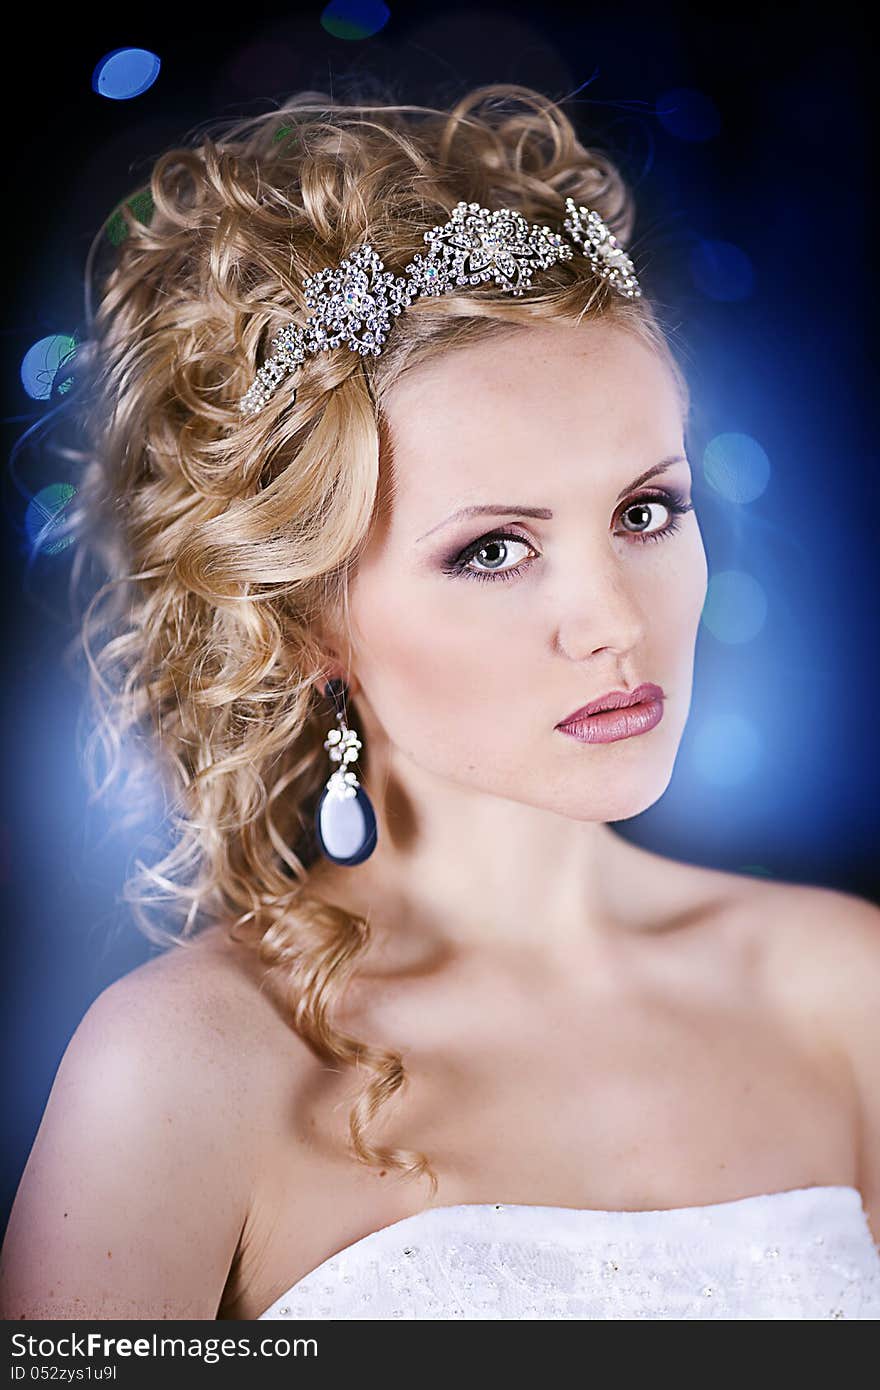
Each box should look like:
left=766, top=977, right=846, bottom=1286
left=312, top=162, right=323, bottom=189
left=314, top=680, right=377, bottom=865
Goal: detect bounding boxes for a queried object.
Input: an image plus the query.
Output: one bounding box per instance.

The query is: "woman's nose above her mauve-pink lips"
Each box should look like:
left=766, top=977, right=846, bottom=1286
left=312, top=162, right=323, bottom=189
left=555, top=556, right=648, bottom=660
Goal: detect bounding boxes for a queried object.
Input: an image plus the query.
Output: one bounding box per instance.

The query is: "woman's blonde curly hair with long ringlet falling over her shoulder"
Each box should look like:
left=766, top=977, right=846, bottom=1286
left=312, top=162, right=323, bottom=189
left=54, top=83, right=687, bottom=1191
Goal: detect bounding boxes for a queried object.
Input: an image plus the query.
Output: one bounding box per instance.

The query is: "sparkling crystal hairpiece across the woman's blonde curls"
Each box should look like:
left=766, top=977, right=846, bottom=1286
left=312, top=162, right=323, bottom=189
left=239, top=197, right=641, bottom=416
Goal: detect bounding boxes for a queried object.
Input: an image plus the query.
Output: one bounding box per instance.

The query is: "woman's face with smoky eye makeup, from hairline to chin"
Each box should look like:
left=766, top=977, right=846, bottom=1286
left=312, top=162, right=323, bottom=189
left=337, top=322, right=706, bottom=821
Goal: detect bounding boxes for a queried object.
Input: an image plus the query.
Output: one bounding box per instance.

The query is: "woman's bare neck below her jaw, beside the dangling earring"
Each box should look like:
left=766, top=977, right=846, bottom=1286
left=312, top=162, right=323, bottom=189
left=310, top=741, right=652, bottom=967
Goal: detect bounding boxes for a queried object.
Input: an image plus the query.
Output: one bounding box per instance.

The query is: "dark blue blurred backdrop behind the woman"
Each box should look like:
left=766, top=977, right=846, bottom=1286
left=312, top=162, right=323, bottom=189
left=0, top=3, right=880, bottom=1228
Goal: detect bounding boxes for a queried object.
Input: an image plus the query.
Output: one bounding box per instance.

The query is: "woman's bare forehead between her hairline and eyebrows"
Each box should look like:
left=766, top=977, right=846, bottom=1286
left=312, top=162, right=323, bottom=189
left=384, top=324, right=681, bottom=499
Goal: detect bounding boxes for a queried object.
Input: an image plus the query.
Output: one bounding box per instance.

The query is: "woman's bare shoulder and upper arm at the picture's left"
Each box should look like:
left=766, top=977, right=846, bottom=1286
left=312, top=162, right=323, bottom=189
left=0, top=937, right=301, bottom=1321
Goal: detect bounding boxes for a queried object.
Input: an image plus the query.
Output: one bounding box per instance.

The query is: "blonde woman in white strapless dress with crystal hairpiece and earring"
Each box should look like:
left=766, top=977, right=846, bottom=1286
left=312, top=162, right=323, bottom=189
left=3, top=86, right=880, bottom=1319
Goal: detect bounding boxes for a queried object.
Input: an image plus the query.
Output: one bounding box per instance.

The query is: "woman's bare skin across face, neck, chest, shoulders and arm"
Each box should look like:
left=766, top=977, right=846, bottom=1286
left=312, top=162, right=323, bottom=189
left=0, top=322, right=880, bottom=1319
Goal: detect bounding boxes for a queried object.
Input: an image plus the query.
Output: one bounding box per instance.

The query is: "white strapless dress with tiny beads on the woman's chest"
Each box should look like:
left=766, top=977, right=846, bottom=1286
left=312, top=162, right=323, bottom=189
left=257, top=1186, right=880, bottom=1321
